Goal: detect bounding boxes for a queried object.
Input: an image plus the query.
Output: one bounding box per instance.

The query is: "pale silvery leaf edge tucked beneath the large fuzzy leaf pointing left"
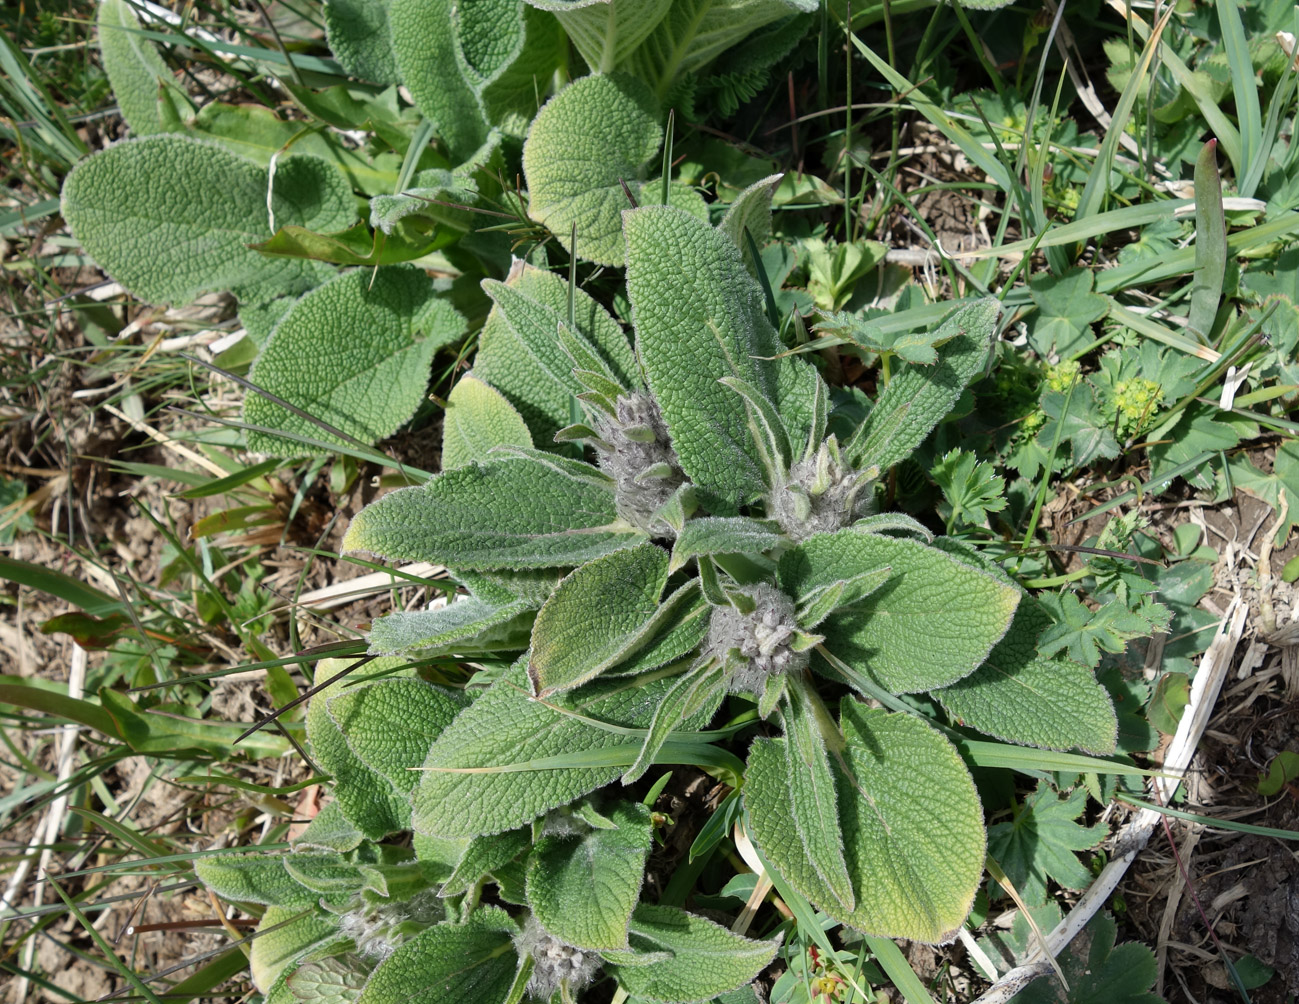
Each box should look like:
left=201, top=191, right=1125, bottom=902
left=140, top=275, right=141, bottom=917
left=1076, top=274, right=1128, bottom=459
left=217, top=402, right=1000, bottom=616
left=370, top=596, right=536, bottom=659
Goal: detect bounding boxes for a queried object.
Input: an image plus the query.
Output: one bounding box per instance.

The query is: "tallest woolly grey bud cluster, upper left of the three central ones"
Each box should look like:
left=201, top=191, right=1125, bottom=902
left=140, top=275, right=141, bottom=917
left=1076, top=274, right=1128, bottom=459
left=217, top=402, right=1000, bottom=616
left=592, top=391, right=686, bottom=529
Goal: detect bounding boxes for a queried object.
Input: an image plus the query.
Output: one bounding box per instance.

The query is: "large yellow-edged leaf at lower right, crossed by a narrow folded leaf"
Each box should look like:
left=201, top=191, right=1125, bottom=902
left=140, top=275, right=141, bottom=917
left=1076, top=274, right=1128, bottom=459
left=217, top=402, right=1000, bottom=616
left=744, top=699, right=985, bottom=943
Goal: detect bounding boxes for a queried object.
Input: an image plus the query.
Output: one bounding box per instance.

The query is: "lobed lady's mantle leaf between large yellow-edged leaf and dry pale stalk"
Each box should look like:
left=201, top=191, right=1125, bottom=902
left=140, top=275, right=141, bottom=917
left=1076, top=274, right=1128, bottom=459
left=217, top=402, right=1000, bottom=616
left=987, top=781, right=1107, bottom=907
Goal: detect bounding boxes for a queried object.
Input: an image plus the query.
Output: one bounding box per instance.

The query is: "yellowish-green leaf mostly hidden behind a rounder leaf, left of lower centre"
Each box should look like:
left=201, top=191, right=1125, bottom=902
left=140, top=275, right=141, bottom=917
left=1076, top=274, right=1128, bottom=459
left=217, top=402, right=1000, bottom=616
left=307, top=659, right=410, bottom=840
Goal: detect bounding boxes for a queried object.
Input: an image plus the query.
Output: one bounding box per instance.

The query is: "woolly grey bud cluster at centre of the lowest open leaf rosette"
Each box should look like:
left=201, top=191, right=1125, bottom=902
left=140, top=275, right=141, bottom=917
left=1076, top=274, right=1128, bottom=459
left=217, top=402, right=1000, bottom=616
left=708, top=582, right=809, bottom=696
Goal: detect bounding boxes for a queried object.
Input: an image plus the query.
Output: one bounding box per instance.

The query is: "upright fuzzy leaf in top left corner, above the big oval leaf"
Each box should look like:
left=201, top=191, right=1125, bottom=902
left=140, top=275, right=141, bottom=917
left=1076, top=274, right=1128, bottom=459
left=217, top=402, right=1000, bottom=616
left=96, top=0, right=194, bottom=136
